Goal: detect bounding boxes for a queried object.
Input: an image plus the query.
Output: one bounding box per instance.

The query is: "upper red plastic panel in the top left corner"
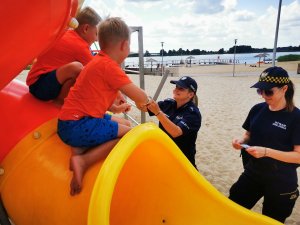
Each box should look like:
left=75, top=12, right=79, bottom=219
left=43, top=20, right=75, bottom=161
left=0, top=0, right=78, bottom=90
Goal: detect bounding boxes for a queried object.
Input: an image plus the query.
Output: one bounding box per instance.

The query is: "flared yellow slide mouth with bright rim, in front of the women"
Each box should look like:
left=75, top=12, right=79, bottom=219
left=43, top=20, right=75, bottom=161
left=88, top=123, right=281, bottom=225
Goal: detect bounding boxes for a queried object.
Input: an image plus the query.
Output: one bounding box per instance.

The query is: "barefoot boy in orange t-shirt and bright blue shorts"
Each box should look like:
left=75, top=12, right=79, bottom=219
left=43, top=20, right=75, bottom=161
left=58, top=17, right=149, bottom=195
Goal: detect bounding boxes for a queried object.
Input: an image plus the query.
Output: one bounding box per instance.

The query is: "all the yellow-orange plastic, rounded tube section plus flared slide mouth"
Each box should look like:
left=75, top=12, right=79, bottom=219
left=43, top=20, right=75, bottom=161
left=0, top=119, right=281, bottom=225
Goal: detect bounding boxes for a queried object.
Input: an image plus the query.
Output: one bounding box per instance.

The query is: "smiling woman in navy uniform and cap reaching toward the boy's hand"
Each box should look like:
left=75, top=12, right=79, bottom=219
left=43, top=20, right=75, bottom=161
left=147, top=76, right=201, bottom=168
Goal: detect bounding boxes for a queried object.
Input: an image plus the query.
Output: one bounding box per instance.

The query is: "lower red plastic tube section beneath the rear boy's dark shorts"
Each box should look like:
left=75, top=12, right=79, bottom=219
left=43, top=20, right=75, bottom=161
left=0, top=80, right=59, bottom=162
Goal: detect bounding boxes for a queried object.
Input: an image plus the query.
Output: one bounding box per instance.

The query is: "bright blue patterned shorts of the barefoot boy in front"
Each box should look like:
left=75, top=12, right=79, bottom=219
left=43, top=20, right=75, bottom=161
left=57, top=114, right=118, bottom=148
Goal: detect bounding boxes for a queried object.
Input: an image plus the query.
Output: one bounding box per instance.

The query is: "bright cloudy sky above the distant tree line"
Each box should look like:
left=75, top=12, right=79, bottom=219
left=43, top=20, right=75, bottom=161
left=84, top=0, right=300, bottom=53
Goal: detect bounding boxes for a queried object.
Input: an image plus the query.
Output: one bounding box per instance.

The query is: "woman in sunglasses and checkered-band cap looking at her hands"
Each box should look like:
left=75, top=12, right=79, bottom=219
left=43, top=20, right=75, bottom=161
left=229, top=67, right=300, bottom=223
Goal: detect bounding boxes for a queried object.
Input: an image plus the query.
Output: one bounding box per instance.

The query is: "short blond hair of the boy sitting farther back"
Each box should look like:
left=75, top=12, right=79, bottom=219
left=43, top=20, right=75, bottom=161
left=76, top=6, right=102, bottom=26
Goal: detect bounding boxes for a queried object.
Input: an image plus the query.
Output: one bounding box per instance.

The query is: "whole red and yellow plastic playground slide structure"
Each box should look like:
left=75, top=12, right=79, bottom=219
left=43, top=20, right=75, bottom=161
left=0, top=0, right=280, bottom=225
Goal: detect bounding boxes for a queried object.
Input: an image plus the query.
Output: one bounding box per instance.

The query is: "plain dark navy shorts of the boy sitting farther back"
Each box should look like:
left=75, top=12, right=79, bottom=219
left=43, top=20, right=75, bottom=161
left=29, top=70, right=62, bottom=101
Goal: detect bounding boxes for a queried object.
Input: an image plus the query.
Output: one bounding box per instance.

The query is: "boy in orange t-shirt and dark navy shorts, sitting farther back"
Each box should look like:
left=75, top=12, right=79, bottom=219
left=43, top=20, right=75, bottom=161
left=26, top=7, right=101, bottom=104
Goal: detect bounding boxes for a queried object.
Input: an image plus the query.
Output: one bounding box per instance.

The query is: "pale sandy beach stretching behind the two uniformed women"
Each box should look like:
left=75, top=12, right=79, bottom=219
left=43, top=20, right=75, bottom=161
left=18, top=61, right=300, bottom=225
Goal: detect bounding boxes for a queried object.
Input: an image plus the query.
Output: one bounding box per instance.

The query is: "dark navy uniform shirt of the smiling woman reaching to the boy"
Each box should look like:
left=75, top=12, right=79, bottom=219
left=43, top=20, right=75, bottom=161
left=152, top=98, right=201, bottom=164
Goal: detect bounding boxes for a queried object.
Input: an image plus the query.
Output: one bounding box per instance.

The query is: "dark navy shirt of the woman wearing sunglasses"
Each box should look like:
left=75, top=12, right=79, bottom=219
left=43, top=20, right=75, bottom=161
left=243, top=102, right=300, bottom=172
